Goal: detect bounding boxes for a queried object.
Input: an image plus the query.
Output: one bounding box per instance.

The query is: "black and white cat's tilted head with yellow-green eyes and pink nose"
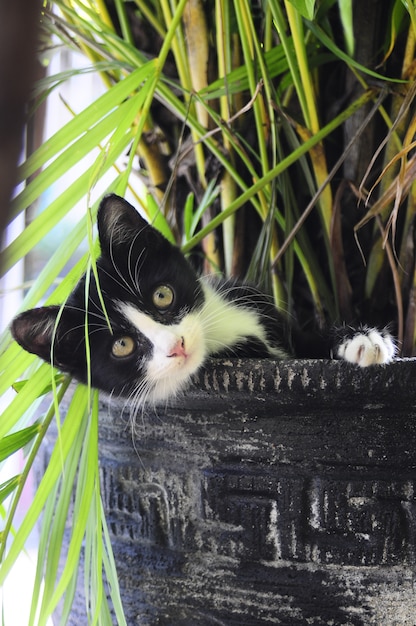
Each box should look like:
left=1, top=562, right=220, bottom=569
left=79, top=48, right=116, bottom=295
left=11, top=195, right=206, bottom=402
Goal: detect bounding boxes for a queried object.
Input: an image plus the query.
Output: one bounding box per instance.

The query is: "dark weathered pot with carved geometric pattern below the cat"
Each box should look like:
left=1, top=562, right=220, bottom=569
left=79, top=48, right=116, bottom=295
left=96, top=360, right=416, bottom=626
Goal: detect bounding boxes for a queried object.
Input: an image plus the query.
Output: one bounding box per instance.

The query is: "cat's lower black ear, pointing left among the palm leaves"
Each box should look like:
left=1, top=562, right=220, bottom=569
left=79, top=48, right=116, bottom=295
left=10, top=306, right=59, bottom=363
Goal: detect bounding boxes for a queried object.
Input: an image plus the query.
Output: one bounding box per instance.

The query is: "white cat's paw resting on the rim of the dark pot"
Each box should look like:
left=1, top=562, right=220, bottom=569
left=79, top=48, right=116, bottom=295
left=336, top=326, right=396, bottom=367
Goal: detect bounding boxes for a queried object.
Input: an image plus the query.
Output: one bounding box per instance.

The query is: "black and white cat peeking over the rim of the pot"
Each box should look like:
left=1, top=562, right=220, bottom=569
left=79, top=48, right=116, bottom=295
left=11, top=195, right=396, bottom=405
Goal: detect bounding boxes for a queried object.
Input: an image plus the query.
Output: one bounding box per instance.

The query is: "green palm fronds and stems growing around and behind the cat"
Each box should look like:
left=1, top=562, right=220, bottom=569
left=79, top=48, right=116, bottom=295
left=0, top=0, right=416, bottom=625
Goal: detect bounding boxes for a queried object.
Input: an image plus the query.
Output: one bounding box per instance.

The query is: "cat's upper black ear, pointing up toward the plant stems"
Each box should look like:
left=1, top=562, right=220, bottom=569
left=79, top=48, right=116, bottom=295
left=97, top=194, right=156, bottom=254
